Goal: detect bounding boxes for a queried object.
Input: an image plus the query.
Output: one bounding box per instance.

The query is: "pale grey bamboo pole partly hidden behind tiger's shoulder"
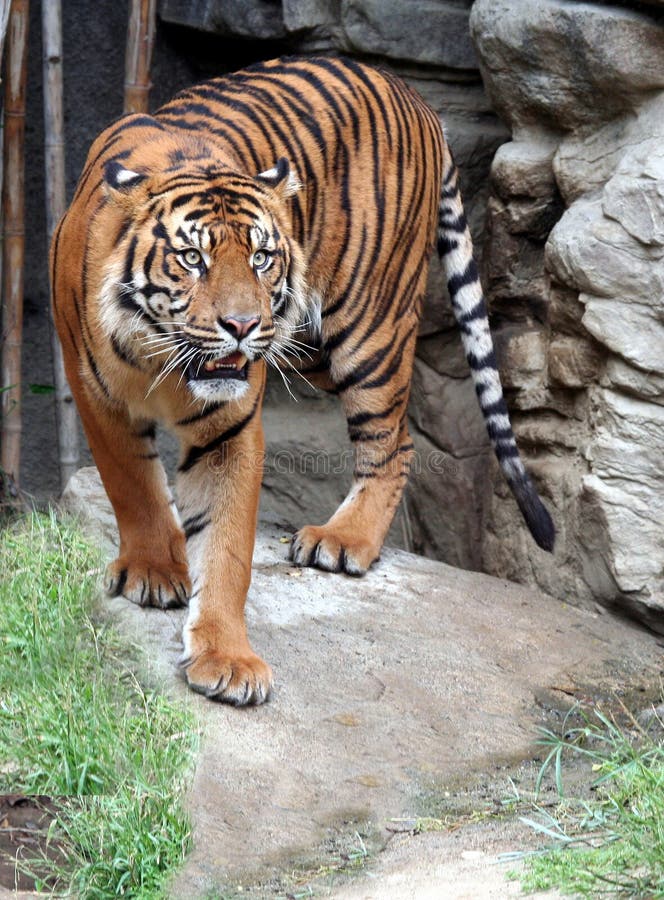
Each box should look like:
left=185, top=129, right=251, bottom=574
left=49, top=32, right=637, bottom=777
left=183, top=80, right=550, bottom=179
left=42, top=0, right=79, bottom=490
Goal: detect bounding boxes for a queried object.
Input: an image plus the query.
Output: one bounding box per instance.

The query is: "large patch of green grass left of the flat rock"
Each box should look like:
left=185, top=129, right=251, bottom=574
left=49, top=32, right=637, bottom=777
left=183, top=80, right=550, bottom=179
left=0, top=514, right=198, bottom=898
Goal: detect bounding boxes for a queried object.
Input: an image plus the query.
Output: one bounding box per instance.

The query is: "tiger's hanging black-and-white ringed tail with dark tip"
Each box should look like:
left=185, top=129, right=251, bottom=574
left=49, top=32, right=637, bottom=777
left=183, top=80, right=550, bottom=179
left=438, top=159, right=555, bottom=551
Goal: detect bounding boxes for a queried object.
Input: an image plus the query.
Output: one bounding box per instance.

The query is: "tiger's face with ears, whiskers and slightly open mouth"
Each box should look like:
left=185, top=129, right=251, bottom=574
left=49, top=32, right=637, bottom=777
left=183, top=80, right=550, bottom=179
left=101, top=160, right=307, bottom=402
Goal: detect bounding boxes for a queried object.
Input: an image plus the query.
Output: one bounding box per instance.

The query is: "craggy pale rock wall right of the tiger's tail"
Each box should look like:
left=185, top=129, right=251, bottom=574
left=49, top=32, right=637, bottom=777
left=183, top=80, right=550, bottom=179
left=471, top=0, right=664, bottom=631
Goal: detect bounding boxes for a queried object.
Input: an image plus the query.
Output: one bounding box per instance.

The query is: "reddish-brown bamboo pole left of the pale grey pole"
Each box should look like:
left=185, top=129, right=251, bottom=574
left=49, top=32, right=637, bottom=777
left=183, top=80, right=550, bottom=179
left=0, top=0, right=29, bottom=484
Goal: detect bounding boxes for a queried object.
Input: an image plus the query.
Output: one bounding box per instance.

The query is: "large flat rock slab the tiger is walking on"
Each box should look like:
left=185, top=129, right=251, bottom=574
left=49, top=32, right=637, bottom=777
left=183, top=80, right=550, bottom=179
left=61, top=470, right=661, bottom=897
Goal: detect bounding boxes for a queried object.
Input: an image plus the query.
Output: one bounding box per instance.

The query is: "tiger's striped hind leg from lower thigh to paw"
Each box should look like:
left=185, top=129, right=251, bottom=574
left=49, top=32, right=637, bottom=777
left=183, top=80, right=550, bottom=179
left=290, top=324, right=417, bottom=575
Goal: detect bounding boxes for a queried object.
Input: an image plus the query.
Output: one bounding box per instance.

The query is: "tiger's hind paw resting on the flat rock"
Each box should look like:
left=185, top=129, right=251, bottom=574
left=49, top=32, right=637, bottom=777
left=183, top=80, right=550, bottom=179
left=289, top=525, right=380, bottom=575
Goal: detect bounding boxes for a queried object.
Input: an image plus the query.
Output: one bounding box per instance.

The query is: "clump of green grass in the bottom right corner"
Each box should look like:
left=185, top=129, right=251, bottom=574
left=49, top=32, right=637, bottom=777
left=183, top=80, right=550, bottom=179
left=519, top=708, right=664, bottom=898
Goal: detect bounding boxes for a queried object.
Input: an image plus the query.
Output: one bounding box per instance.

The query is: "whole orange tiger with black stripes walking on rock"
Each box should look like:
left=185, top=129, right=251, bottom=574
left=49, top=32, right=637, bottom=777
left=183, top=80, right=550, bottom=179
left=50, top=56, right=555, bottom=706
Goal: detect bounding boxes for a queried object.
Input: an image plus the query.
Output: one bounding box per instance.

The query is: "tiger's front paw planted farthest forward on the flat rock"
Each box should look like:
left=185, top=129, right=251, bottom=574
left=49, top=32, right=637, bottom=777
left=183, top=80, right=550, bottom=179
left=181, top=647, right=272, bottom=706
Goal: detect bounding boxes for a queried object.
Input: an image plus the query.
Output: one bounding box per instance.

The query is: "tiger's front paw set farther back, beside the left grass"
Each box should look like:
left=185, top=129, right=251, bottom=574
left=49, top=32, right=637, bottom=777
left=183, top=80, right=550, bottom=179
left=104, top=556, right=191, bottom=609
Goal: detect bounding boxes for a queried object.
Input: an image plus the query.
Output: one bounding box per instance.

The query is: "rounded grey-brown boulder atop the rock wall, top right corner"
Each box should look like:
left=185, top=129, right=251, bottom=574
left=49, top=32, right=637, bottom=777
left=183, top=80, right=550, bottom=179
left=470, top=0, right=664, bottom=132
